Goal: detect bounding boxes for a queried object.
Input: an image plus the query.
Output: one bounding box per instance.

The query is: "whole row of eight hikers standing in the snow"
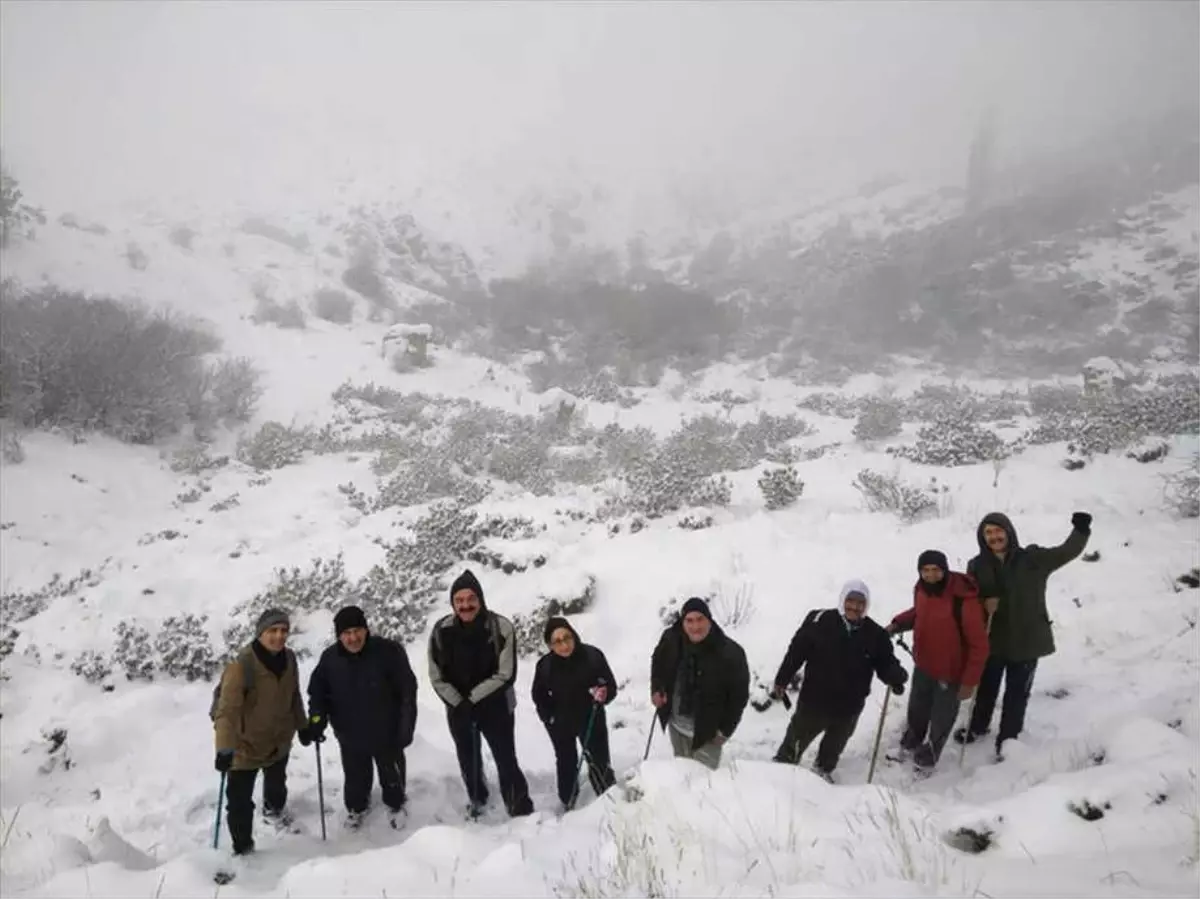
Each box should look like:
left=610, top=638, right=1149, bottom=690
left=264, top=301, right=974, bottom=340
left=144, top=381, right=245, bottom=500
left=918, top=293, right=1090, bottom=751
left=211, top=513, right=1092, bottom=855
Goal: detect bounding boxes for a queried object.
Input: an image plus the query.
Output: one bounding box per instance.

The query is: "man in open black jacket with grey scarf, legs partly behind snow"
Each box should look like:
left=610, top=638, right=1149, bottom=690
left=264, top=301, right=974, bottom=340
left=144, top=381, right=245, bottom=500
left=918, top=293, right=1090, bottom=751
left=650, top=597, right=750, bottom=771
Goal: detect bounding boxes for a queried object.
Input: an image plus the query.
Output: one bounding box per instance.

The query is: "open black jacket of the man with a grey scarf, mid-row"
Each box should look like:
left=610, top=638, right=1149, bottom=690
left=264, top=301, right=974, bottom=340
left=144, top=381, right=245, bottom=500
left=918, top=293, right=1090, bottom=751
left=650, top=619, right=750, bottom=747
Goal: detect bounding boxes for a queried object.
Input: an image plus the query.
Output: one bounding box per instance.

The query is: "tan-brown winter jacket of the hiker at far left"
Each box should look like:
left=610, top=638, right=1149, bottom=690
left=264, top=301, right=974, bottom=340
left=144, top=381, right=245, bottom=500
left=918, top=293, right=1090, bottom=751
left=212, top=643, right=306, bottom=771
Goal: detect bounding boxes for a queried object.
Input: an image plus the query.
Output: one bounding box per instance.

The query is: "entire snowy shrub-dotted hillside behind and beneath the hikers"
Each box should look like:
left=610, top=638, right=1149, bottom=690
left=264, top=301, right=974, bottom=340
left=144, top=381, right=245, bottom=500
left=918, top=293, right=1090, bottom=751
left=0, top=108, right=1200, bottom=897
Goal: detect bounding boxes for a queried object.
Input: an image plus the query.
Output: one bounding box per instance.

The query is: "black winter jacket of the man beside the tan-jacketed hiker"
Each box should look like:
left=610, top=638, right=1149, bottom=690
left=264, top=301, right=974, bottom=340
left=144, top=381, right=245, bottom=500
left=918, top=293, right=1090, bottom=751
left=308, top=635, right=416, bottom=754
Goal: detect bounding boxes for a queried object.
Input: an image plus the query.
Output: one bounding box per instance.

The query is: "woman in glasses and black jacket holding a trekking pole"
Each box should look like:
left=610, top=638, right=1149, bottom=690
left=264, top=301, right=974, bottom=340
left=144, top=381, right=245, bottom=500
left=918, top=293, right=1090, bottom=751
left=533, top=618, right=617, bottom=810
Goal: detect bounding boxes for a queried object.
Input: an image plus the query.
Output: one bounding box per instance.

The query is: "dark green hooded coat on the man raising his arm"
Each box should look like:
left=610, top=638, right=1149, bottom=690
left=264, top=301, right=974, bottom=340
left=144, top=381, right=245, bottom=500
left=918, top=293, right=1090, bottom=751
left=967, top=513, right=1088, bottom=661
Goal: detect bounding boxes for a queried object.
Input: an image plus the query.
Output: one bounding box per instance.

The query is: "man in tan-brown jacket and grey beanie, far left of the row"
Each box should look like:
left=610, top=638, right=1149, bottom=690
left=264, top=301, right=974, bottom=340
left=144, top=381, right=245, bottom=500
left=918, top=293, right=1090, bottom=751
left=212, top=609, right=312, bottom=856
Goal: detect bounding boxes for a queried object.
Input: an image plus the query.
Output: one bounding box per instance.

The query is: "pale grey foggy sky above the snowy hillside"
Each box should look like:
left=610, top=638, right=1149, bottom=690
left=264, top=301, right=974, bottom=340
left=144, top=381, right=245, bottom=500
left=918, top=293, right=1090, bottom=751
left=0, top=0, right=1200, bottom=222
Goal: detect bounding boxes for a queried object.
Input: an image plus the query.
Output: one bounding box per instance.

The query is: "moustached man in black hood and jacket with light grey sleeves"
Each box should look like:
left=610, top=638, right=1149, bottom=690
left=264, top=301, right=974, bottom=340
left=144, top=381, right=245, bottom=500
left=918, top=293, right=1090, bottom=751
left=428, top=570, right=533, bottom=817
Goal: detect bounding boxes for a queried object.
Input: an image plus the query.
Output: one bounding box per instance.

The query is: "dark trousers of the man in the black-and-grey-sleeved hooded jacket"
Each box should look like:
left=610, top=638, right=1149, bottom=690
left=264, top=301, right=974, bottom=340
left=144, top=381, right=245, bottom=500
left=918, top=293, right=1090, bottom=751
left=446, top=696, right=533, bottom=815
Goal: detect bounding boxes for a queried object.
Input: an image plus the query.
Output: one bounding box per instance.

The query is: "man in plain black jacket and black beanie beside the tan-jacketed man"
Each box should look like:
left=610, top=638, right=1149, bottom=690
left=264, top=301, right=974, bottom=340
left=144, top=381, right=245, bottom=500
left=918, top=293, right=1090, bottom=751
left=308, top=606, right=416, bottom=827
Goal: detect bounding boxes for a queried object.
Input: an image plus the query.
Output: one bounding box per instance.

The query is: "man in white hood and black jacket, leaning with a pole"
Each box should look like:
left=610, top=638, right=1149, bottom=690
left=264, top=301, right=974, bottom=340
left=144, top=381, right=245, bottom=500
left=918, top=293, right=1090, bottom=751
left=774, top=581, right=908, bottom=781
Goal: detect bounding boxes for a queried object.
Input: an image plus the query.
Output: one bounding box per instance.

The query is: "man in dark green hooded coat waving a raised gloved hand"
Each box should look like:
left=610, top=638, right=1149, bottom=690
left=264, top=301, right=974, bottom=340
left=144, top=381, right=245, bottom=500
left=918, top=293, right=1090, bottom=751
left=954, top=513, right=1092, bottom=755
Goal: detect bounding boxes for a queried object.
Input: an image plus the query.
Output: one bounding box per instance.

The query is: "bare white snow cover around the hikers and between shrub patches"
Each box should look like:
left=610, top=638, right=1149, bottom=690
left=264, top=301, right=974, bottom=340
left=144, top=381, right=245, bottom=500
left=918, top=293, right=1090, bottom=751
left=0, top=183, right=1200, bottom=897
